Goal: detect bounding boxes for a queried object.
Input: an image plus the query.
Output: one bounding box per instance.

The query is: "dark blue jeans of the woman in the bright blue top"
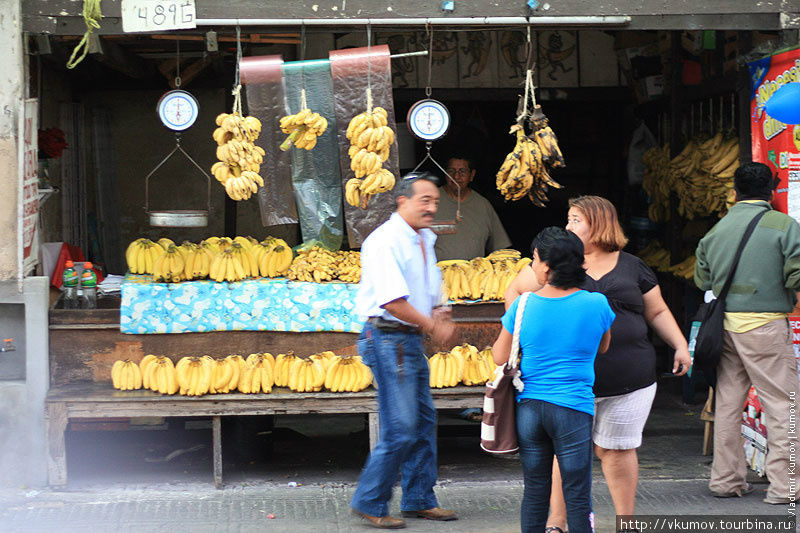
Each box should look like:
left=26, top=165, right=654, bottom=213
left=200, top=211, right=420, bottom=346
left=517, top=399, right=594, bottom=533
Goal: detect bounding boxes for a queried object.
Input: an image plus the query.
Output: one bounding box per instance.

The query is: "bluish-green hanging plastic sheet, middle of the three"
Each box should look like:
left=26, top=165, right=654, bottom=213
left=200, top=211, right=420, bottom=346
left=283, top=59, right=346, bottom=250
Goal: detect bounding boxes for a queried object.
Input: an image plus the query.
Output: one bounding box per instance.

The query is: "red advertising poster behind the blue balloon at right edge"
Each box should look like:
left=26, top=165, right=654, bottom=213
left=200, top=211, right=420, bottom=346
left=749, top=48, right=800, bottom=218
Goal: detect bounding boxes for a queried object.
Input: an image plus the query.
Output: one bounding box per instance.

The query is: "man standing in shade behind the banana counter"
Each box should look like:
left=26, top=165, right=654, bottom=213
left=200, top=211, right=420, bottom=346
left=436, top=154, right=511, bottom=261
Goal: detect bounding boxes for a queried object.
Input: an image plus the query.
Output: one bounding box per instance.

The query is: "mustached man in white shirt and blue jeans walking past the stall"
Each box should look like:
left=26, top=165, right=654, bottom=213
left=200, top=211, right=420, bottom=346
left=350, top=173, right=458, bottom=529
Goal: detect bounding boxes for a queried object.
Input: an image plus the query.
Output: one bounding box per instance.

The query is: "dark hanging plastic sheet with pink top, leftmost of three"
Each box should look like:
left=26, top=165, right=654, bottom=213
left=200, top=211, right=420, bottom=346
left=239, top=56, right=298, bottom=226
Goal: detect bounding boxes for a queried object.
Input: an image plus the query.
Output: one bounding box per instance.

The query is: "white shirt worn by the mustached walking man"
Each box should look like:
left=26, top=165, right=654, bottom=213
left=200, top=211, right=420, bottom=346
left=356, top=213, right=442, bottom=322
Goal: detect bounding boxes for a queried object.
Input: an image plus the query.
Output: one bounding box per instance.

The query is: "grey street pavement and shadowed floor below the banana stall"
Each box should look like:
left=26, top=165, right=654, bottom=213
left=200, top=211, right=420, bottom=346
left=0, top=384, right=800, bottom=533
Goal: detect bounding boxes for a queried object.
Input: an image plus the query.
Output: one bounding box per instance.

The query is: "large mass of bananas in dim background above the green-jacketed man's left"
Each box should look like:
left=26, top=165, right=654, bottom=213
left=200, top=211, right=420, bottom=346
left=642, top=132, right=740, bottom=222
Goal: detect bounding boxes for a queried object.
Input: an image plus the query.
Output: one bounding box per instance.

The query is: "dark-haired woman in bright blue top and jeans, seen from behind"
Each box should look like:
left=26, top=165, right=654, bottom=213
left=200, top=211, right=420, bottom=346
left=493, top=227, right=615, bottom=533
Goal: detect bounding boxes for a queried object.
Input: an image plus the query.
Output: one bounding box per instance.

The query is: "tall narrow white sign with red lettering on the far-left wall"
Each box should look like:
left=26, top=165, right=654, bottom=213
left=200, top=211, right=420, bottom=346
left=19, top=98, right=39, bottom=276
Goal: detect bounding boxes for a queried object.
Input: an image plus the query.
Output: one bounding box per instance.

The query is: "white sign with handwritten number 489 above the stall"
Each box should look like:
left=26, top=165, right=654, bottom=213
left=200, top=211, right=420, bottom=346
left=122, top=0, right=197, bottom=33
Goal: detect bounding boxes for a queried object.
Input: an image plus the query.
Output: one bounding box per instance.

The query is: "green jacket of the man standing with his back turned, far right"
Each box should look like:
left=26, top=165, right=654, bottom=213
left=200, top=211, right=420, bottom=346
left=694, top=202, right=800, bottom=313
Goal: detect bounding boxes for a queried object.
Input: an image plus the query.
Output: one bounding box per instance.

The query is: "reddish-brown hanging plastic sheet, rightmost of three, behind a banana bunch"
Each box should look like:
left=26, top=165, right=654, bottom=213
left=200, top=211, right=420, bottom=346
left=330, top=45, right=399, bottom=248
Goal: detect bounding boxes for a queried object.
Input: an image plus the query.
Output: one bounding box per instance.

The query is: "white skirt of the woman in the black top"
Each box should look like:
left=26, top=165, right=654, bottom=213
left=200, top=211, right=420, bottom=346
left=592, top=383, right=656, bottom=450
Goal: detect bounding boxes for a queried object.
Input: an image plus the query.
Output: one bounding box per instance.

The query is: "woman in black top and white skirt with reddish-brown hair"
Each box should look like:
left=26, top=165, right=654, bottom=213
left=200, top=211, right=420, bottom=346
left=505, top=196, right=691, bottom=532
